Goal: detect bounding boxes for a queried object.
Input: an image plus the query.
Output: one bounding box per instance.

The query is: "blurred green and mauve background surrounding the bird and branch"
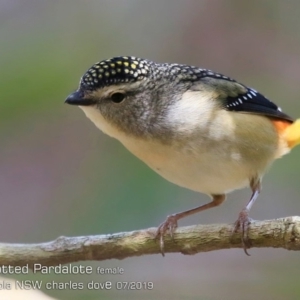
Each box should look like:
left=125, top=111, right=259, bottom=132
left=0, top=0, right=300, bottom=300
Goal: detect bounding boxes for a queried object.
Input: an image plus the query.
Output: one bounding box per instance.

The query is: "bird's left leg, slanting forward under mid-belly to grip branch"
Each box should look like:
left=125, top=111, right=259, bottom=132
left=156, top=194, right=225, bottom=256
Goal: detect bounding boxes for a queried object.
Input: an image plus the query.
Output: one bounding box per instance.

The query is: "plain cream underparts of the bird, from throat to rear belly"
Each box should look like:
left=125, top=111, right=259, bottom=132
left=81, top=106, right=277, bottom=194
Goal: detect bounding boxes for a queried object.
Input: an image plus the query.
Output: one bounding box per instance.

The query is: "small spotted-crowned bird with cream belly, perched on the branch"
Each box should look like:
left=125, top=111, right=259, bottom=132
left=65, top=56, right=300, bottom=255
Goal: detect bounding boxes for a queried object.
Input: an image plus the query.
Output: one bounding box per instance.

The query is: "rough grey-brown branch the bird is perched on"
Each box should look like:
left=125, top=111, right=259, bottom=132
left=0, top=217, right=300, bottom=268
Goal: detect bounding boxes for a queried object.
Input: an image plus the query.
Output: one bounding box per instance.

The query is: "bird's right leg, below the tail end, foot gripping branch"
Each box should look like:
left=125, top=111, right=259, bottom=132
left=233, top=178, right=261, bottom=256
